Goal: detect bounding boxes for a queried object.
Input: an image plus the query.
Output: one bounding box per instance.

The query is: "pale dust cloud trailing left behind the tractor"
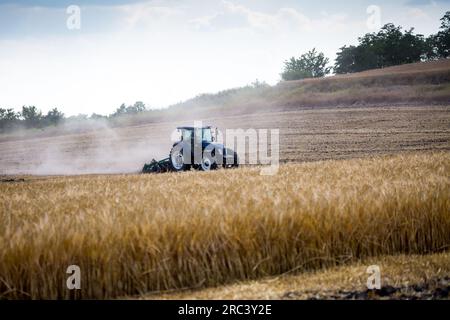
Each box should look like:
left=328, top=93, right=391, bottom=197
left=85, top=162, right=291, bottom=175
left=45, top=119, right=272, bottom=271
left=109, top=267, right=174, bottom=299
left=0, top=121, right=173, bottom=175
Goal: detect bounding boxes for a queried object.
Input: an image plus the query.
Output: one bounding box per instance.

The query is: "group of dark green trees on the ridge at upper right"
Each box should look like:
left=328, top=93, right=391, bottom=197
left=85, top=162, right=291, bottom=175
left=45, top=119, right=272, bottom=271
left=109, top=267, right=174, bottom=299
left=281, top=11, right=450, bottom=80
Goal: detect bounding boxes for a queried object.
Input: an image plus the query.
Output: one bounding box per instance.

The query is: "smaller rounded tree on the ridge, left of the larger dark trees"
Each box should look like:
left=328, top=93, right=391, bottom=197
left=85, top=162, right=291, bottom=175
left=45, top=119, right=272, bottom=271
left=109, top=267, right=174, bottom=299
left=281, top=48, right=331, bottom=80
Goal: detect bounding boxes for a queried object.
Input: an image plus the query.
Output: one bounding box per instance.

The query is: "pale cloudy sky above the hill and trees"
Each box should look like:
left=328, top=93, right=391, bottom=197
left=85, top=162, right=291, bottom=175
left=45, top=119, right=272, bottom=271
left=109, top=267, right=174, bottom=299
left=0, top=0, right=450, bottom=116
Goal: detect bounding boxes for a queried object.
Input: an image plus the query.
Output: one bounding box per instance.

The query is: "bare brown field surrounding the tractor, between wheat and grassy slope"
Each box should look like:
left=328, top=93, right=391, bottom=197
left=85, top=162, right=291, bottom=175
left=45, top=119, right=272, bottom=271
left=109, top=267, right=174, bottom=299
left=0, top=105, right=450, bottom=174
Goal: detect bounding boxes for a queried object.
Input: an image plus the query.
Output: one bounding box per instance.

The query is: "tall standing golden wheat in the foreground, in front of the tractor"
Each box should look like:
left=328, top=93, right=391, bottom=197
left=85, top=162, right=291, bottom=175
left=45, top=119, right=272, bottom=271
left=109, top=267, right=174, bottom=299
left=0, top=152, right=450, bottom=299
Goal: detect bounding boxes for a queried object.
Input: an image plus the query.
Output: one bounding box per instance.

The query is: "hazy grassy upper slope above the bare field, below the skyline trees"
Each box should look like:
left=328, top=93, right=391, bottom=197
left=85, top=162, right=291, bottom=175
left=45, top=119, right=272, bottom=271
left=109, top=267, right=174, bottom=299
left=0, top=59, right=450, bottom=141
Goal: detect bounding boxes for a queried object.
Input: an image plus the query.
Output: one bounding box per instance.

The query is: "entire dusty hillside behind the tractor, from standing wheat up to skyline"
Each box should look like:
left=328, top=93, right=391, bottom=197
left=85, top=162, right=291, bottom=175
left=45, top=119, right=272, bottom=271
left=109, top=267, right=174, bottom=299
left=0, top=60, right=450, bottom=174
